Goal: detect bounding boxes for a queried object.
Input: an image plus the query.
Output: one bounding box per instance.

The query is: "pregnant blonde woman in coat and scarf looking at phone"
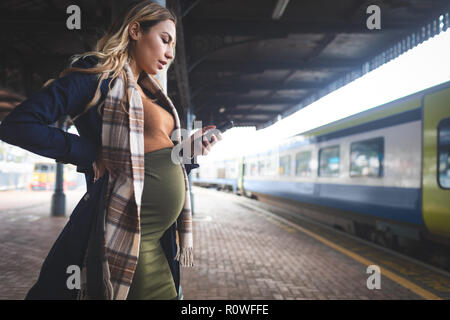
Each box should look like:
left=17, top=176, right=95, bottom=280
left=0, top=1, right=222, bottom=299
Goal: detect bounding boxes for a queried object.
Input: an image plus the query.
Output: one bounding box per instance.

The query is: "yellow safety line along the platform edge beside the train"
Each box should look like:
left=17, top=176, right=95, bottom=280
left=244, top=204, right=442, bottom=300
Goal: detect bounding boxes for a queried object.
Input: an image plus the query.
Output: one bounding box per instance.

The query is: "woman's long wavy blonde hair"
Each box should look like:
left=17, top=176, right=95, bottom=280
left=44, top=1, right=177, bottom=121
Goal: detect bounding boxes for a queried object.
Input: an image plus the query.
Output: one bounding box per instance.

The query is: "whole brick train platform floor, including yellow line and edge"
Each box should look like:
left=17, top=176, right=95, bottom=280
left=0, top=187, right=450, bottom=300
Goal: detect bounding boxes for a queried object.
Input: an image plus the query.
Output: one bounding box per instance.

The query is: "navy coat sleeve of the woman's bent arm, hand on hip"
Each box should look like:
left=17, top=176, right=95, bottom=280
left=0, top=72, right=98, bottom=166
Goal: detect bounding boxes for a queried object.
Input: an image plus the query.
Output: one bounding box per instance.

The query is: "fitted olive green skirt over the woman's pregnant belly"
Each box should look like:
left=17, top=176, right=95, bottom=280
left=127, top=148, right=185, bottom=300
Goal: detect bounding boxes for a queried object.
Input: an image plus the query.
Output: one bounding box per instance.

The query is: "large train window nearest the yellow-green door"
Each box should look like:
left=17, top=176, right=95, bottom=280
left=350, top=137, right=384, bottom=177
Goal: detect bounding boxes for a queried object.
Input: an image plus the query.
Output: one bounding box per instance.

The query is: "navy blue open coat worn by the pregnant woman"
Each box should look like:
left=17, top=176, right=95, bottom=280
left=0, top=57, right=198, bottom=299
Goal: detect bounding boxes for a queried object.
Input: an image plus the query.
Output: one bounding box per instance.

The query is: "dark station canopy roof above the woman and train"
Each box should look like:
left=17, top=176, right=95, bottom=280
left=0, top=0, right=449, bottom=128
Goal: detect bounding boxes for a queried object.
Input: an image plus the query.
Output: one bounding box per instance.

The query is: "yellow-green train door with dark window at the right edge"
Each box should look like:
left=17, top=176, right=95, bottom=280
left=422, top=87, right=450, bottom=237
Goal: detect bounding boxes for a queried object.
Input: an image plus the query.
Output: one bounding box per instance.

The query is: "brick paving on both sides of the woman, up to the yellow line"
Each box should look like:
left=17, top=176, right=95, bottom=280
left=0, top=187, right=428, bottom=300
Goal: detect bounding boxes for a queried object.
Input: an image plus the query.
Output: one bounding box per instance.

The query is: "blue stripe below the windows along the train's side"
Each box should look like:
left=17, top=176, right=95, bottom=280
left=244, top=179, right=423, bottom=225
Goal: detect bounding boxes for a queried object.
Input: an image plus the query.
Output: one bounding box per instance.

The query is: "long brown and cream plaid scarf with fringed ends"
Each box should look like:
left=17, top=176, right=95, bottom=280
left=78, top=63, right=194, bottom=300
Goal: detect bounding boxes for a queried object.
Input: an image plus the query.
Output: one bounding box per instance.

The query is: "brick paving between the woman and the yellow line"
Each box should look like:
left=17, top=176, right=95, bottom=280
left=181, top=188, right=422, bottom=300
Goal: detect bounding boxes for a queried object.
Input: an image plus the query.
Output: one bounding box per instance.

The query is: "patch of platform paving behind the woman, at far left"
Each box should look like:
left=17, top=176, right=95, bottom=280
left=0, top=189, right=85, bottom=299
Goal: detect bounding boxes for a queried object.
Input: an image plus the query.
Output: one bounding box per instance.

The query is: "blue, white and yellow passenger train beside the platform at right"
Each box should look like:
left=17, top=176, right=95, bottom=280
left=191, top=81, right=450, bottom=252
